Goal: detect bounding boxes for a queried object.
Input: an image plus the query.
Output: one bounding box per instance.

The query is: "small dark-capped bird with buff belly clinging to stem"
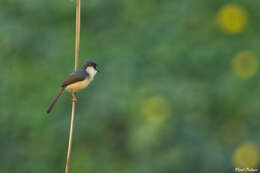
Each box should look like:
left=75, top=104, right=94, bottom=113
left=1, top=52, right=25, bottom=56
left=47, top=60, right=99, bottom=114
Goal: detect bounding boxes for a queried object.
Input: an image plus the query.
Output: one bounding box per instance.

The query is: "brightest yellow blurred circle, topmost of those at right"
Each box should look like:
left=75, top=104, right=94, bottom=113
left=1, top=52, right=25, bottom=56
left=217, top=4, right=248, bottom=34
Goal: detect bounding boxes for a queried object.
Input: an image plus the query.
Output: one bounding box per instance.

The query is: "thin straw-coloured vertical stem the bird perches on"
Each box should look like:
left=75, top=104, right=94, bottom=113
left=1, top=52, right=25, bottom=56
left=65, top=0, right=80, bottom=173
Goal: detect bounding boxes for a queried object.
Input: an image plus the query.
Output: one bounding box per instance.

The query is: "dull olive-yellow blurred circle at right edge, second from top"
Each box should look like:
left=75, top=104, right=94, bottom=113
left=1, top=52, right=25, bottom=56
left=232, top=51, right=258, bottom=79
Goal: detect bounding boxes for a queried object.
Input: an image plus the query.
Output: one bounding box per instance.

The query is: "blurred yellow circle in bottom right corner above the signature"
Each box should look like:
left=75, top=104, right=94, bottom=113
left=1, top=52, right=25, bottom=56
left=233, top=142, right=259, bottom=168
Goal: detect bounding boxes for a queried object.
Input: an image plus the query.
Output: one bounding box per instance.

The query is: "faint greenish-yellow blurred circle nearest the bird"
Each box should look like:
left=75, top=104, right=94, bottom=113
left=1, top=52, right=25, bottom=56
left=141, top=96, right=171, bottom=123
